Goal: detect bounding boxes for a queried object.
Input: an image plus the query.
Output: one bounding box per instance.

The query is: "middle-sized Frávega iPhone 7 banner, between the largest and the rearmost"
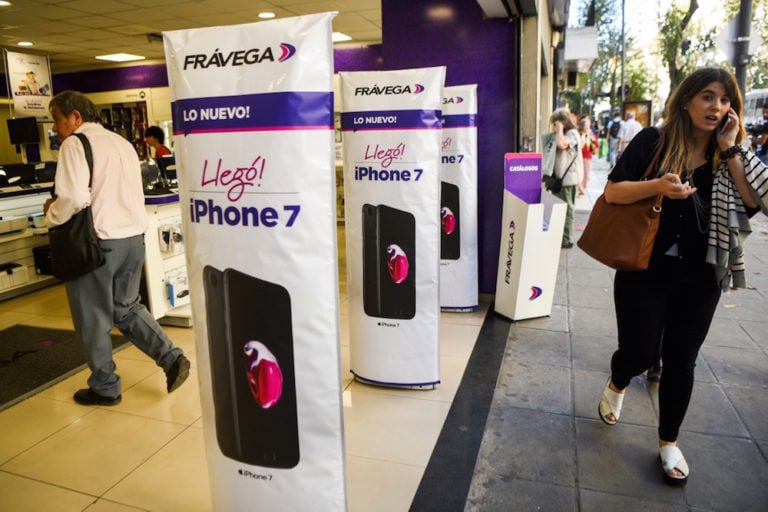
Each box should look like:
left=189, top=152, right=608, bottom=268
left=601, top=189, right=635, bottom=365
left=340, top=67, right=445, bottom=387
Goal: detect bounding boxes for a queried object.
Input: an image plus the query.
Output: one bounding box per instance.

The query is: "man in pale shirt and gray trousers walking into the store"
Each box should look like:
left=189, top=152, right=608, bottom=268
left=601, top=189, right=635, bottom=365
left=44, top=91, right=190, bottom=405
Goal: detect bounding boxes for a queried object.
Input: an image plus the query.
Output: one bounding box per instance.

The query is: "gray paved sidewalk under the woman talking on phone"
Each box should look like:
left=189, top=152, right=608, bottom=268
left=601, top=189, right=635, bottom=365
left=466, top=160, right=768, bottom=512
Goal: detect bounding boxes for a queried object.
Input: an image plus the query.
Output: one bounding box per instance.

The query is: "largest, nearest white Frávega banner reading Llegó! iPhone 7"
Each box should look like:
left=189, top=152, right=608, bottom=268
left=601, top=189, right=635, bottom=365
left=164, top=13, right=346, bottom=510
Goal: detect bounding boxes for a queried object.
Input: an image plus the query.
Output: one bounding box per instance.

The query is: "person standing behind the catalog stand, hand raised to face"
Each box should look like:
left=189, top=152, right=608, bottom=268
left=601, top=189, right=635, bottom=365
left=549, top=108, right=584, bottom=249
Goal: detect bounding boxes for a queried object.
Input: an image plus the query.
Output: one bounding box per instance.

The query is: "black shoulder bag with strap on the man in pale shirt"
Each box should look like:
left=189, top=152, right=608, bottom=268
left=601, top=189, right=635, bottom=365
left=48, top=133, right=105, bottom=281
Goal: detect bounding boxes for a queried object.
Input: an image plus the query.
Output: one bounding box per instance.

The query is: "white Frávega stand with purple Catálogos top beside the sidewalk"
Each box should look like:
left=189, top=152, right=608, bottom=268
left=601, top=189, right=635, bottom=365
left=494, top=153, right=566, bottom=320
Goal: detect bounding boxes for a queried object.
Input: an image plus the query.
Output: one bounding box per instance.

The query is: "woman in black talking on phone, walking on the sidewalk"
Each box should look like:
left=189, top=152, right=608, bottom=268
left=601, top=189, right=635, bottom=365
left=598, top=68, right=768, bottom=484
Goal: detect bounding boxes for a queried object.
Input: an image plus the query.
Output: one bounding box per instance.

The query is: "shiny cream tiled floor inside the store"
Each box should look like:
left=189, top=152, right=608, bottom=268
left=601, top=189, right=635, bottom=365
left=0, top=234, right=488, bottom=512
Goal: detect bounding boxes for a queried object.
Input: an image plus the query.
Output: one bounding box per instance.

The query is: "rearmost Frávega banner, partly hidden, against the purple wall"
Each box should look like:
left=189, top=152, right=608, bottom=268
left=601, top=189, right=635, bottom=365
left=440, top=84, right=478, bottom=311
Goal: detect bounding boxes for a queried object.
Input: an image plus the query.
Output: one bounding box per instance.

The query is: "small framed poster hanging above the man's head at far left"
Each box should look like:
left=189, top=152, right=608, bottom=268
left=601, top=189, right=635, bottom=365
left=5, top=50, right=53, bottom=120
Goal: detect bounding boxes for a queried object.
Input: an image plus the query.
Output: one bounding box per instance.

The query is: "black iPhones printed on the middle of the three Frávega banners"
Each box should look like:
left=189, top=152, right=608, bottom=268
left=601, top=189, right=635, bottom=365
left=363, top=204, right=416, bottom=319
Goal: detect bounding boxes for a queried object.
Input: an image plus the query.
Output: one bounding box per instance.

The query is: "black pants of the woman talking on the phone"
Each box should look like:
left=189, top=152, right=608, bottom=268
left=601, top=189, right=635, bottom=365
left=611, top=256, right=720, bottom=442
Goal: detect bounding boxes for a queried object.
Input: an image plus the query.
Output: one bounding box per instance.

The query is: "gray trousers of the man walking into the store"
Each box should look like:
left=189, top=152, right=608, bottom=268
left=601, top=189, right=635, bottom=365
left=66, top=235, right=183, bottom=398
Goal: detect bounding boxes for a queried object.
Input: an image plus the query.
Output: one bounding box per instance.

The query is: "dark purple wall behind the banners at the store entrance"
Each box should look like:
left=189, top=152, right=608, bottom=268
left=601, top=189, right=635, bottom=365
left=382, top=0, right=517, bottom=293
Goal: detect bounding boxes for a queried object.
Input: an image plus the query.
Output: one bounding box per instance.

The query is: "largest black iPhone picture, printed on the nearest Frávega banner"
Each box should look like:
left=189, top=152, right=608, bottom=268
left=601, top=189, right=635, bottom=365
left=204, top=269, right=299, bottom=468
